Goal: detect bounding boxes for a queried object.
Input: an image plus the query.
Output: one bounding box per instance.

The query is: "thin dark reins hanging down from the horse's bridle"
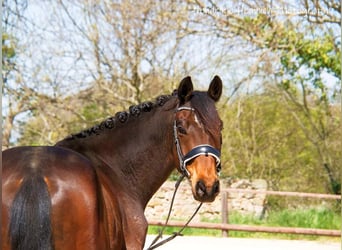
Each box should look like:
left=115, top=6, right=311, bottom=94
left=146, top=174, right=203, bottom=250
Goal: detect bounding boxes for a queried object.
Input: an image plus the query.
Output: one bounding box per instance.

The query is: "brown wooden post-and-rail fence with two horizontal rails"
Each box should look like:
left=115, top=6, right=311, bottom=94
left=148, top=188, right=341, bottom=237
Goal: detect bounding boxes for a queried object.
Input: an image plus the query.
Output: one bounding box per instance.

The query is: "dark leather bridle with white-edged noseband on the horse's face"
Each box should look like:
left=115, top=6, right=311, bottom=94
left=173, top=107, right=221, bottom=178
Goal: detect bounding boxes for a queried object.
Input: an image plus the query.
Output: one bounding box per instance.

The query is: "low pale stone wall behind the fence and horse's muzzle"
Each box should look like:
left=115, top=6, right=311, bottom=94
left=145, top=179, right=267, bottom=221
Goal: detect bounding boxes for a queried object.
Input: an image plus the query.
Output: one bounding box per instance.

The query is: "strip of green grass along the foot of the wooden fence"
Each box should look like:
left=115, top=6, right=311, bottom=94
left=148, top=208, right=342, bottom=241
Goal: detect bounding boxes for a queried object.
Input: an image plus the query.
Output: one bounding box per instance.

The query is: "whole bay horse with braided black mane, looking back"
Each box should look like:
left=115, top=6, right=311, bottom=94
left=1, top=76, right=222, bottom=250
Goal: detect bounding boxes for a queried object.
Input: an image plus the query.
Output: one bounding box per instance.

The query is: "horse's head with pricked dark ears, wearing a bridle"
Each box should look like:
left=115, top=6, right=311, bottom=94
left=174, top=76, right=222, bottom=202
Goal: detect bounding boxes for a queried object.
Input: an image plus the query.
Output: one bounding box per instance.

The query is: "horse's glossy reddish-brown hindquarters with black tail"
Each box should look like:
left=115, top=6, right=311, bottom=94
left=2, top=147, right=121, bottom=249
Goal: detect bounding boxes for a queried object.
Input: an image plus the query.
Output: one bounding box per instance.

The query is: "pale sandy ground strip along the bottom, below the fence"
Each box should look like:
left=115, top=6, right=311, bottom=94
left=146, top=235, right=341, bottom=250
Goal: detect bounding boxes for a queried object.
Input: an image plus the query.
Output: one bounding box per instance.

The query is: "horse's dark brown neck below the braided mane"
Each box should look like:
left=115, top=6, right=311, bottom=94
left=57, top=101, right=177, bottom=207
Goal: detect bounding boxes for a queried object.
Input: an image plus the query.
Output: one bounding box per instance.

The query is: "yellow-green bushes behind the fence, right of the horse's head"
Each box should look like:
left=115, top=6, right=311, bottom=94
left=221, top=93, right=341, bottom=193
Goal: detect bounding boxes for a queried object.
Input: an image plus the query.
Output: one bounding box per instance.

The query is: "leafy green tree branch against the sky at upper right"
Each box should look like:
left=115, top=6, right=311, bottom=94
left=247, top=14, right=341, bottom=77
